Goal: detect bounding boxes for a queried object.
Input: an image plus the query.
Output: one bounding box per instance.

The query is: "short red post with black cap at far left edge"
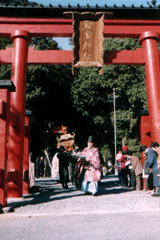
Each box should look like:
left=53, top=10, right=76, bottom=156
left=0, top=80, right=15, bottom=207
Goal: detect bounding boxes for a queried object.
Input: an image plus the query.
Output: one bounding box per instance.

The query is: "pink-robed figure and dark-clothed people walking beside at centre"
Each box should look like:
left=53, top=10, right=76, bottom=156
left=52, top=136, right=102, bottom=196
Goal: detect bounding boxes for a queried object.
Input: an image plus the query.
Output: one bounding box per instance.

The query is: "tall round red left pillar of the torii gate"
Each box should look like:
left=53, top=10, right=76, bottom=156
left=7, top=30, right=30, bottom=198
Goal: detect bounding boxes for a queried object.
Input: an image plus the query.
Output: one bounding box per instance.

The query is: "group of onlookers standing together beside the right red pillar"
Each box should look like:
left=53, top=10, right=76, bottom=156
left=115, top=142, right=160, bottom=197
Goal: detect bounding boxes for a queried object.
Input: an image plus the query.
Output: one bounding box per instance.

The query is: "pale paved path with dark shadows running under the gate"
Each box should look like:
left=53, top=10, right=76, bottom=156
left=0, top=175, right=160, bottom=240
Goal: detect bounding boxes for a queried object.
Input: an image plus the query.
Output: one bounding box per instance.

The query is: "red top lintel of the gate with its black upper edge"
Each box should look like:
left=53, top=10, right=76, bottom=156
left=0, top=5, right=160, bottom=38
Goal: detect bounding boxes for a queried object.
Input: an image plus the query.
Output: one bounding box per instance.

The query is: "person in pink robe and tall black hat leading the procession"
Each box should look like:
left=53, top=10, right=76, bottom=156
left=81, top=136, right=102, bottom=196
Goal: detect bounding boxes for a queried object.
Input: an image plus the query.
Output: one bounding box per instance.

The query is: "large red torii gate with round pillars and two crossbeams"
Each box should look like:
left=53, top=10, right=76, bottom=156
left=0, top=7, right=160, bottom=206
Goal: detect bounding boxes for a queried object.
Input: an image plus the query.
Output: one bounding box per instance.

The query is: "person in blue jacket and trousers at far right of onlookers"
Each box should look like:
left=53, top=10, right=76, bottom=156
left=147, top=142, right=159, bottom=196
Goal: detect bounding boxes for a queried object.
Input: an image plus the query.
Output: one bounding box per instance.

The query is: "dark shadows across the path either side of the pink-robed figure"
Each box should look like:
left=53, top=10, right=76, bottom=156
left=8, top=175, right=132, bottom=209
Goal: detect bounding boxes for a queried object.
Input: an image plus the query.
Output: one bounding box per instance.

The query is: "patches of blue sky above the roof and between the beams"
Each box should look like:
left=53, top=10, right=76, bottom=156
left=29, top=0, right=156, bottom=50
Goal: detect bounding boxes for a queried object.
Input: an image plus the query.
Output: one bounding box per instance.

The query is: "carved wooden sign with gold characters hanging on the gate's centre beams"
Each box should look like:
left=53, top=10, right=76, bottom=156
left=65, top=12, right=105, bottom=74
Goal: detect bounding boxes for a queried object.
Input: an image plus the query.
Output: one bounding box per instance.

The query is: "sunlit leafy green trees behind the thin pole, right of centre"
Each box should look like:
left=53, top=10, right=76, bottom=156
left=71, top=38, right=147, bottom=158
